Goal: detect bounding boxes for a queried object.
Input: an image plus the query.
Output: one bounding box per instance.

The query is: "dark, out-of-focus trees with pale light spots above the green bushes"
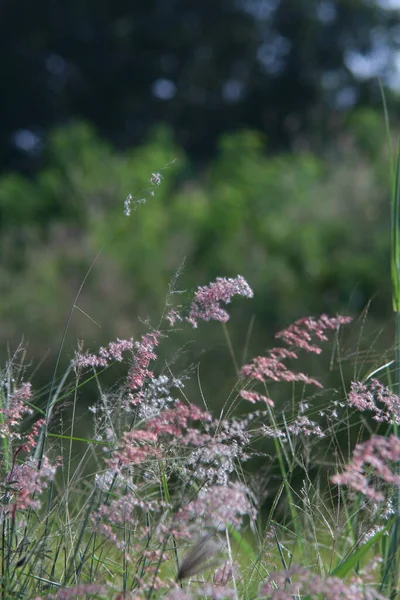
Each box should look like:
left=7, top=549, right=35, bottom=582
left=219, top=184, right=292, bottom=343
left=0, top=0, right=399, bottom=171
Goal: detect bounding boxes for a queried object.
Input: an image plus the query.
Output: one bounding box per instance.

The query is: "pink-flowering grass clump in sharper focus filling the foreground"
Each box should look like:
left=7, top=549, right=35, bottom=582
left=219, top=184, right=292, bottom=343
left=0, top=165, right=400, bottom=600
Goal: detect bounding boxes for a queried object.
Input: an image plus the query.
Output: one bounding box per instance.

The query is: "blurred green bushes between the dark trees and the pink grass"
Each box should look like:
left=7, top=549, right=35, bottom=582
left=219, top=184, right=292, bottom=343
left=0, top=111, right=390, bottom=404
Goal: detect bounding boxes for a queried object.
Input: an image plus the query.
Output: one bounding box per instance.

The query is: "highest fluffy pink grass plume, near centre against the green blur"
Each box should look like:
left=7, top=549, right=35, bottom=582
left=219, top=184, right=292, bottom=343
left=187, top=275, right=254, bottom=327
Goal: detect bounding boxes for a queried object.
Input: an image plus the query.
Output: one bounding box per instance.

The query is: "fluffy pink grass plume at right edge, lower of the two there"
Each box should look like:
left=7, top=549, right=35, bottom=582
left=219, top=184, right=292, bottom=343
left=332, top=435, right=400, bottom=501
